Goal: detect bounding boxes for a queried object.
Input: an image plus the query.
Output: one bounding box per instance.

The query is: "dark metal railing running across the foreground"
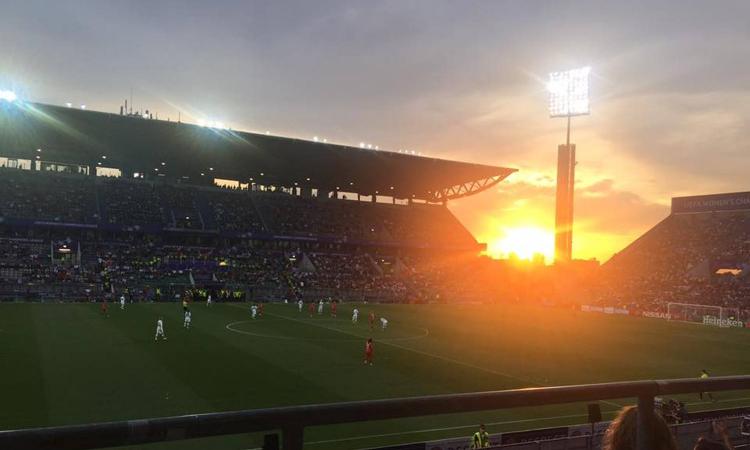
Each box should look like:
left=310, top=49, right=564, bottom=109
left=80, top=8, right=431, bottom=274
left=0, top=376, right=750, bottom=450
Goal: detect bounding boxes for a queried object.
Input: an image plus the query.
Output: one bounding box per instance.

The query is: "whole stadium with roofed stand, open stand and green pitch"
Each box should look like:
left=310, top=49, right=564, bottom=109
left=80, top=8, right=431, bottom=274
left=0, top=96, right=750, bottom=448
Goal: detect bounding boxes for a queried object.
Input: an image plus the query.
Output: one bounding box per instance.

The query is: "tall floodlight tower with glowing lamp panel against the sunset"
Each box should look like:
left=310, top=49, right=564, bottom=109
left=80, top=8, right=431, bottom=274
left=547, top=67, right=591, bottom=263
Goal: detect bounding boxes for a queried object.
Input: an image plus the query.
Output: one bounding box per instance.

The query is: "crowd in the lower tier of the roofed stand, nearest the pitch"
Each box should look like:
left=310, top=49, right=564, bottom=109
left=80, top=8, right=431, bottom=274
left=0, top=225, right=476, bottom=302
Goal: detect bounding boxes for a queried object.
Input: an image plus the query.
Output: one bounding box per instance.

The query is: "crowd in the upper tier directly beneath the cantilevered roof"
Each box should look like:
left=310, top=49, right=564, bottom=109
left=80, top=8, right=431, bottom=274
left=0, top=169, right=476, bottom=248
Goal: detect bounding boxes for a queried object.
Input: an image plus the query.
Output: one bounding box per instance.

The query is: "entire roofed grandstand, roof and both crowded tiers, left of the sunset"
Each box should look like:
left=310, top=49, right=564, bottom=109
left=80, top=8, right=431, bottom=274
left=0, top=103, right=513, bottom=302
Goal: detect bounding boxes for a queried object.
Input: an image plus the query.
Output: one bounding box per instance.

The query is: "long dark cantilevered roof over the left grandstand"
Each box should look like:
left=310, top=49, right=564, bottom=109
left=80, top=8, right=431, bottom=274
left=0, top=102, right=515, bottom=201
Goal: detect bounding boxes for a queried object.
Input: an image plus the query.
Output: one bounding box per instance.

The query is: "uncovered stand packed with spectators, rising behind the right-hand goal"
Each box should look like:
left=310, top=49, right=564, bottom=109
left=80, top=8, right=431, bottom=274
left=595, top=192, right=750, bottom=324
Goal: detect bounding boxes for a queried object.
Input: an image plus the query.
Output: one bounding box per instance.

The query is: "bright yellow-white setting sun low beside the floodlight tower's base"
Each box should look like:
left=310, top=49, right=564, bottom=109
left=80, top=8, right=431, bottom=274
left=487, top=227, right=555, bottom=262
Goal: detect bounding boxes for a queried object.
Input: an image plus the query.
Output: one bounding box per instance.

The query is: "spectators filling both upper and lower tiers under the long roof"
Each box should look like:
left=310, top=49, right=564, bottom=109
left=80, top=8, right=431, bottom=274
left=0, top=170, right=560, bottom=302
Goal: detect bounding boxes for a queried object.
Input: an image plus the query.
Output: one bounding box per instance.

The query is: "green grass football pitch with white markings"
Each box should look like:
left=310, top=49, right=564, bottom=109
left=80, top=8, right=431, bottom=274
left=0, top=303, right=750, bottom=450
